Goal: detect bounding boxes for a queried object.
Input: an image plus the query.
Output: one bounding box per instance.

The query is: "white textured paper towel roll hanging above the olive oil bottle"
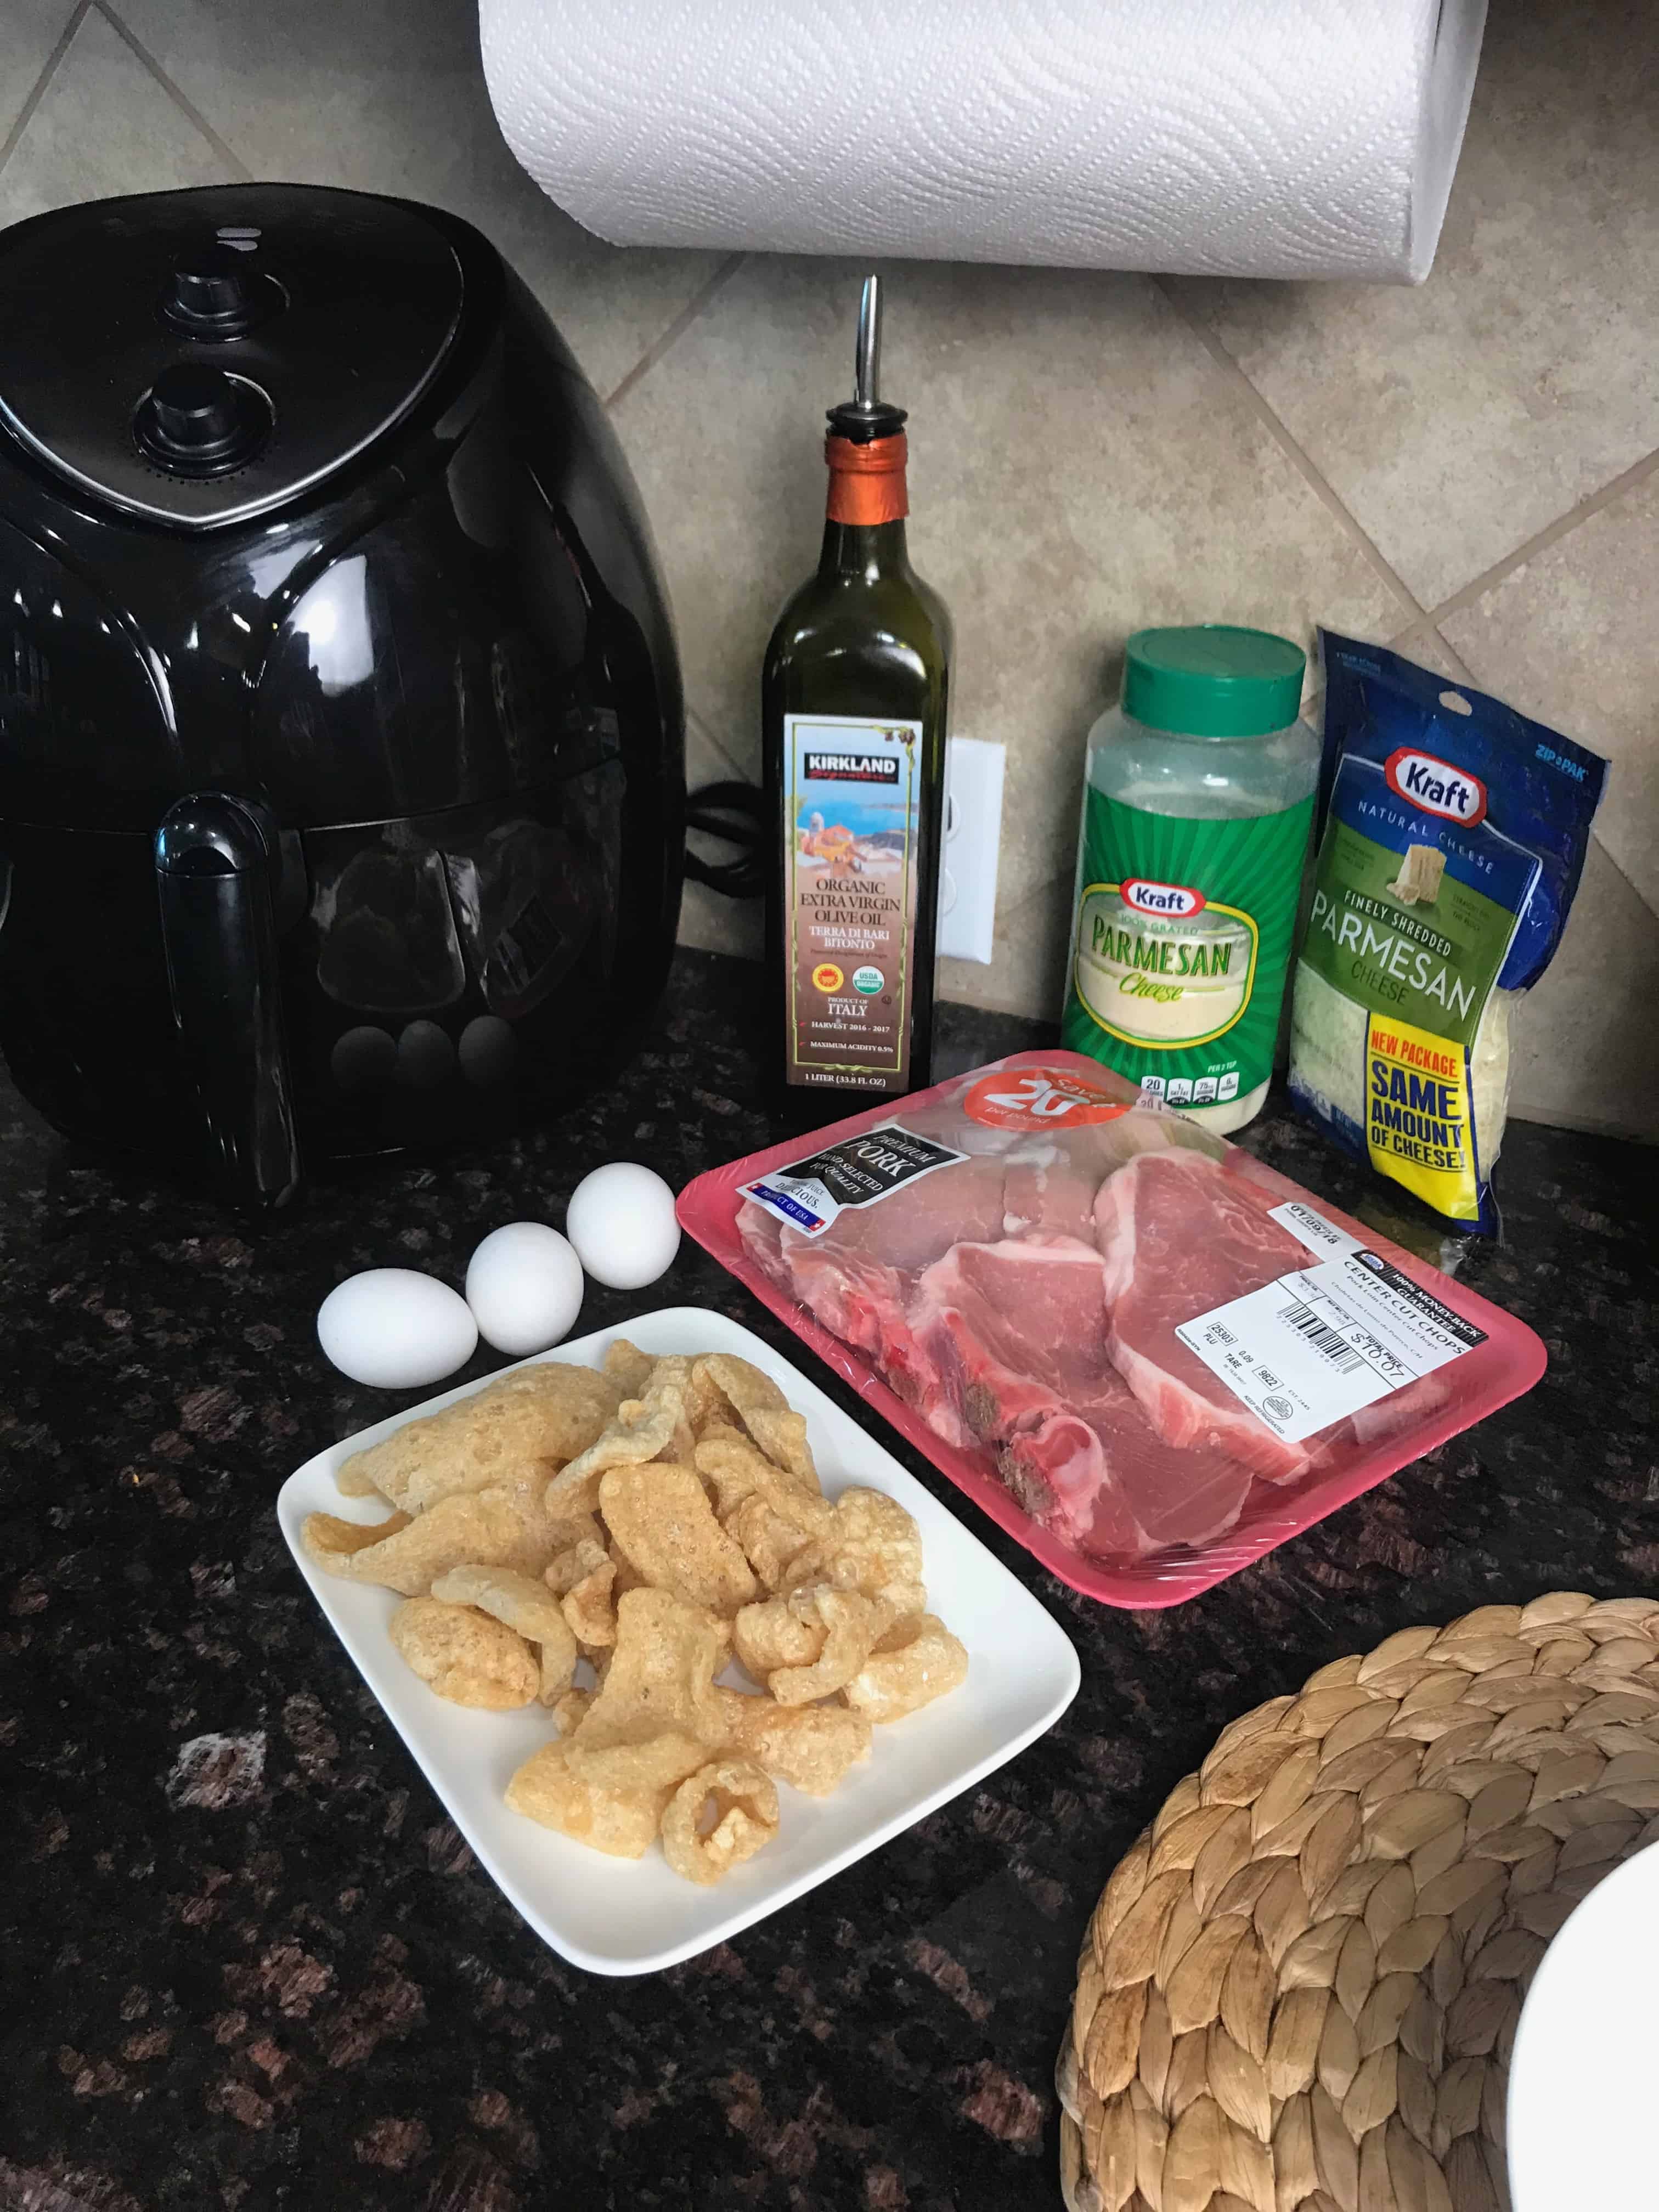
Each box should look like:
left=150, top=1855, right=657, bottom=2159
left=480, top=0, right=1487, bottom=281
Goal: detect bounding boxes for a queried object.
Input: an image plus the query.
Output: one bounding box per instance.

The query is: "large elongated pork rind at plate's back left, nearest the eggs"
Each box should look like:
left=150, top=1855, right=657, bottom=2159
left=336, top=1361, right=622, bottom=1513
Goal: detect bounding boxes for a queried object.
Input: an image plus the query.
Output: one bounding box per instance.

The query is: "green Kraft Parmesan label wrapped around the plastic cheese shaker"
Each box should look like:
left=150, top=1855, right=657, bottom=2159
left=1062, top=789, right=1314, bottom=1106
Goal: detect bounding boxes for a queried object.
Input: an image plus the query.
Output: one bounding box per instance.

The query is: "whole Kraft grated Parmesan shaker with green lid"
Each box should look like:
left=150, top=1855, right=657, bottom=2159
left=1062, top=624, right=1318, bottom=1135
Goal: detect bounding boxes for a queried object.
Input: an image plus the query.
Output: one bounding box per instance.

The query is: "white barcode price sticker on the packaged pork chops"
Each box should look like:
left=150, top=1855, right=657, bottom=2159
left=1175, top=1256, right=1487, bottom=1444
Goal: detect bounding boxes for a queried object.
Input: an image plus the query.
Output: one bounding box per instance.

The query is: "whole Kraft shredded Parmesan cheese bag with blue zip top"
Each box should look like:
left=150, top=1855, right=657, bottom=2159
left=1290, top=630, right=1608, bottom=1230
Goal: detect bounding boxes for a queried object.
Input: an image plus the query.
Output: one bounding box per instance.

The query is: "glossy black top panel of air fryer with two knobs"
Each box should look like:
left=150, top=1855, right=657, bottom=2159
left=0, top=184, right=462, bottom=529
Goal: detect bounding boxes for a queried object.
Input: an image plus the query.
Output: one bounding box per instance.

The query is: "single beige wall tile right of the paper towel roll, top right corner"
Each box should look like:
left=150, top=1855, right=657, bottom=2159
left=1179, top=0, right=1659, bottom=608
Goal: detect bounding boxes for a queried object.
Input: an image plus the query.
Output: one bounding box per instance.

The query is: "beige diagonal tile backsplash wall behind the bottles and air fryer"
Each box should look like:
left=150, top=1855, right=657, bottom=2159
left=0, top=0, right=1659, bottom=1137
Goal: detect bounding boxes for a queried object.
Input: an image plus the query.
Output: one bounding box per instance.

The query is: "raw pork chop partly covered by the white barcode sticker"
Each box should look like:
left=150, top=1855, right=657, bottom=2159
left=1095, top=1150, right=1307, bottom=1482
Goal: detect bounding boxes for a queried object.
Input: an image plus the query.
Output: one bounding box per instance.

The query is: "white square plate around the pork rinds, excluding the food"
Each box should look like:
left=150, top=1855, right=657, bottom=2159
left=276, top=1305, right=1082, bottom=1973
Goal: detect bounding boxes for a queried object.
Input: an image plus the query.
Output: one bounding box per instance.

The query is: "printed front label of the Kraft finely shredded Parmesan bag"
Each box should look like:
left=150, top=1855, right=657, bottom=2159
left=1292, top=750, right=1539, bottom=1221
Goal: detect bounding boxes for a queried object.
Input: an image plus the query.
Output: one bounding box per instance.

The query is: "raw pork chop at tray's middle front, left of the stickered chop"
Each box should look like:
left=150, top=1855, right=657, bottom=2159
left=909, top=1237, right=1250, bottom=1558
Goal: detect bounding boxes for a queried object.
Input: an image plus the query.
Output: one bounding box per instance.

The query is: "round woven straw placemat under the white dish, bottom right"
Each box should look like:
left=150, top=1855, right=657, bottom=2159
left=1057, top=1593, right=1659, bottom=2212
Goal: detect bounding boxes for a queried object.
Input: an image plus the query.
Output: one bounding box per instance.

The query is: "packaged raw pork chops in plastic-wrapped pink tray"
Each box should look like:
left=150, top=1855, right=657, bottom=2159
left=679, top=1051, right=1544, bottom=1606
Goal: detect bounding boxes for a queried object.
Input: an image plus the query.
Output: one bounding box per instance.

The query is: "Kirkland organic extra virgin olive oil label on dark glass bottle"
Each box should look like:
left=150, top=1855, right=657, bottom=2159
left=783, top=714, right=922, bottom=1093
